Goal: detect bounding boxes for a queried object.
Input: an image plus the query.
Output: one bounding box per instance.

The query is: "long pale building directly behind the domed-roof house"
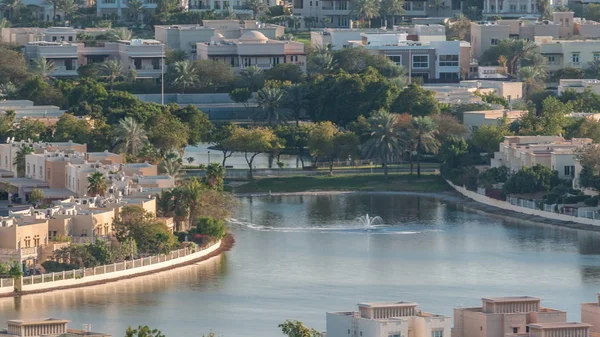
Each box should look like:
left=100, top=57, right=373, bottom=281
left=154, top=20, right=285, bottom=59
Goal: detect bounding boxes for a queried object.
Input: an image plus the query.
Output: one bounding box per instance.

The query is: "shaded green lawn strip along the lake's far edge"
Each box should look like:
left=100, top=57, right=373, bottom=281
left=234, top=173, right=451, bottom=193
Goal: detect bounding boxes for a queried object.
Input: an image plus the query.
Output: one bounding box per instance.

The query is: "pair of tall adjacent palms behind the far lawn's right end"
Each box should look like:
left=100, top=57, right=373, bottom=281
left=362, top=110, right=439, bottom=176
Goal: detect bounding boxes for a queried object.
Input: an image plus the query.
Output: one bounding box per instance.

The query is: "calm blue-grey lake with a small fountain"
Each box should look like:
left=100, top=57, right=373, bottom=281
left=0, top=194, right=600, bottom=337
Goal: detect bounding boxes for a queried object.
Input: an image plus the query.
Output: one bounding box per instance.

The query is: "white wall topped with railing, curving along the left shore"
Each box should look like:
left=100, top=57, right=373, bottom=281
left=0, top=240, right=221, bottom=294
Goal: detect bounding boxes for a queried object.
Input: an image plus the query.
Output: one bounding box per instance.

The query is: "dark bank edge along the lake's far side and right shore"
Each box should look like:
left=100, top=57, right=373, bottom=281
left=234, top=190, right=600, bottom=232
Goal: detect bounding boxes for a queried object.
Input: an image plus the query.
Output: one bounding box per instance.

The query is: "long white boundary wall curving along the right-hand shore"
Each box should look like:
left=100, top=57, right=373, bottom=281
left=446, top=180, right=600, bottom=226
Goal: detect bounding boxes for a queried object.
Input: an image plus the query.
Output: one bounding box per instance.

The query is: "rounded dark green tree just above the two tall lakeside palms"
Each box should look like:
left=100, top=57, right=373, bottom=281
left=391, top=83, right=440, bottom=116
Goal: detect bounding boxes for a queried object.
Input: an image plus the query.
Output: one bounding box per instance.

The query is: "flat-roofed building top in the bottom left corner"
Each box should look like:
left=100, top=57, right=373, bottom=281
left=0, top=318, right=111, bottom=337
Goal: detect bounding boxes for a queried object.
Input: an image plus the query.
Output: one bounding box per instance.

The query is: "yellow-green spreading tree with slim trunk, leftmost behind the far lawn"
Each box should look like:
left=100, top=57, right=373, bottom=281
left=228, top=127, right=282, bottom=179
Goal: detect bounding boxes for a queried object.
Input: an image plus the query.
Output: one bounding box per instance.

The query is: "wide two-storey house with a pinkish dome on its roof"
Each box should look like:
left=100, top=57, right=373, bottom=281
left=196, top=31, right=306, bottom=71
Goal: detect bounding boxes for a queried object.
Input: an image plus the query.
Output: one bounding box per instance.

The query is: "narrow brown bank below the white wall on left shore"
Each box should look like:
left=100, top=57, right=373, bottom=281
left=0, top=233, right=235, bottom=298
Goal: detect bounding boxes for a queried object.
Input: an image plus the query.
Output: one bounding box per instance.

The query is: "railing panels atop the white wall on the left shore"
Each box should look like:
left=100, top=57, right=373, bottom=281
left=0, top=241, right=216, bottom=288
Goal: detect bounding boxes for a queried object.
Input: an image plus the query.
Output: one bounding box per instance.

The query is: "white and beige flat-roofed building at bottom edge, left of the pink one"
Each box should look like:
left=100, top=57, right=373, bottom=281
left=327, top=302, right=452, bottom=337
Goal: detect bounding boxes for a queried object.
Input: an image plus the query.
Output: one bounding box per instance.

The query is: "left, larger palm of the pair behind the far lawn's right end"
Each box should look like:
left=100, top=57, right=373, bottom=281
left=363, top=110, right=405, bottom=177
